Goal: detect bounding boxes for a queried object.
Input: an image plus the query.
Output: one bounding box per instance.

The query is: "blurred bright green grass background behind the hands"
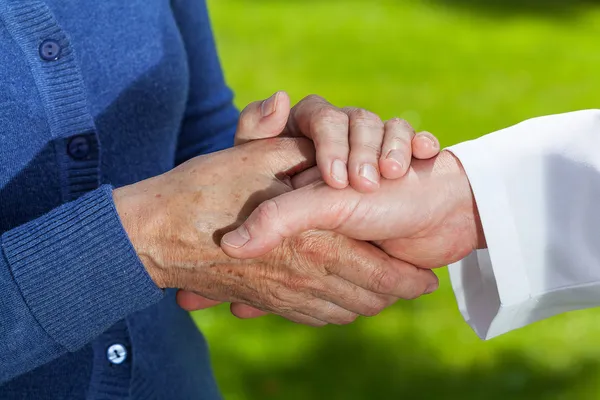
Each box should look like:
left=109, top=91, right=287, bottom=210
left=194, top=0, right=600, bottom=400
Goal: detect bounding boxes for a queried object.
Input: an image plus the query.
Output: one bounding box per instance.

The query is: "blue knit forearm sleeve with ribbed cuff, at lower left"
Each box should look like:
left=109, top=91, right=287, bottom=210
left=0, top=186, right=163, bottom=383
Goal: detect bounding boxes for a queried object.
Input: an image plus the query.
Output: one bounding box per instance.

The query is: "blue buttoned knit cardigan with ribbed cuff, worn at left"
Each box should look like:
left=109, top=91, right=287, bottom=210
left=0, top=0, right=238, bottom=400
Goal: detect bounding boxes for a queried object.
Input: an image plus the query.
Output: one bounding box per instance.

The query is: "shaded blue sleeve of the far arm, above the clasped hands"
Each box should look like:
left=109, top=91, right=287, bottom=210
left=172, top=0, right=239, bottom=164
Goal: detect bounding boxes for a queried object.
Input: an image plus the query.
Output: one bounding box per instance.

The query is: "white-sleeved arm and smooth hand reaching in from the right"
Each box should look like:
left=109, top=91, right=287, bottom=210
left=216, top=111, right=600, bottom=338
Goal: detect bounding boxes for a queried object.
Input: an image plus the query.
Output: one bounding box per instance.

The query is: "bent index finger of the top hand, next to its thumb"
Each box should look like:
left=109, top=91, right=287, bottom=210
left=287, top=95, right=350, bottom=189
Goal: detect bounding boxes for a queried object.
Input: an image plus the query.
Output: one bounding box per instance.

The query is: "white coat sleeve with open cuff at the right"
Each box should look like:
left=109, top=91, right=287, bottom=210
left=447, top=110, right=600, bottom=339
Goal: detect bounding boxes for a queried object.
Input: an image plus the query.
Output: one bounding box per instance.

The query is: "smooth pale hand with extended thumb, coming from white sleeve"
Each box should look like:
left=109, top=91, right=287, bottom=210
left=221, top=151, right=485, bottom=268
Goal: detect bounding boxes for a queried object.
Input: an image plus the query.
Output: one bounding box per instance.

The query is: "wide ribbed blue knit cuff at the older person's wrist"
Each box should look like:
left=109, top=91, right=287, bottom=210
left=2, top=186, right=163, bottom=351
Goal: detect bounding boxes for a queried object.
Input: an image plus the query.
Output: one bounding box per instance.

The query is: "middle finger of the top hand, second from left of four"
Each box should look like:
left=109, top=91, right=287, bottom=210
left=344, top=108, right=384, bottom=192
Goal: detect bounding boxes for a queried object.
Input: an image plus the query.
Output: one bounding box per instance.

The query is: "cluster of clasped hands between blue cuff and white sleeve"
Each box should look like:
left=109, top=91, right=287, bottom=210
left=113, top=92, right=485, bottom=326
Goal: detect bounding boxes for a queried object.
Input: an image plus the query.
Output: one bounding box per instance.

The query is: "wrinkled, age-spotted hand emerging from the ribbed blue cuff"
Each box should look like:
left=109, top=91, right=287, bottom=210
left=114, top=134, right=437, bottom=325
